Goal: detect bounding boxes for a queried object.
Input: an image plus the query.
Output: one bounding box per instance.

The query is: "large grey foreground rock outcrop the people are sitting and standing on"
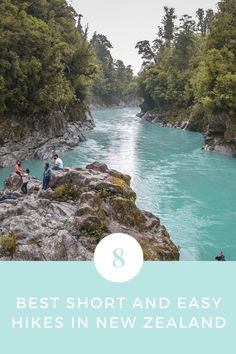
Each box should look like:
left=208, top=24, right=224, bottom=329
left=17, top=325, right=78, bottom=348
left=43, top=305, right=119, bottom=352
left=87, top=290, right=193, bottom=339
left=0, top=162, right=179, bottom=261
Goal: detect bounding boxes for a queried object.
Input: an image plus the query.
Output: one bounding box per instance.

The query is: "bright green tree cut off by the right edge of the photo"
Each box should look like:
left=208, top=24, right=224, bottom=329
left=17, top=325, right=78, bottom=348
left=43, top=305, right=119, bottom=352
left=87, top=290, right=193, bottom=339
left=194, top=0, right=236, bottom=119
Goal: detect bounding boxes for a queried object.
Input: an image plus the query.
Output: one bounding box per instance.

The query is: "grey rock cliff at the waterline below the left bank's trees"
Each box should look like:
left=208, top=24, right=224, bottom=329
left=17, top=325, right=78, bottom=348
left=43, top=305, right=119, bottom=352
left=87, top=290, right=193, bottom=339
left=0, top=108, right=95, bottom=167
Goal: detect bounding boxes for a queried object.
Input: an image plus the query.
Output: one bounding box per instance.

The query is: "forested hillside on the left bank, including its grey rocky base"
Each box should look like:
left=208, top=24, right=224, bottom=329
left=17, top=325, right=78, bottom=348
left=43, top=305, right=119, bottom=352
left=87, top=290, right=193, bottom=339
left=0, top=0, right=136, bottom=167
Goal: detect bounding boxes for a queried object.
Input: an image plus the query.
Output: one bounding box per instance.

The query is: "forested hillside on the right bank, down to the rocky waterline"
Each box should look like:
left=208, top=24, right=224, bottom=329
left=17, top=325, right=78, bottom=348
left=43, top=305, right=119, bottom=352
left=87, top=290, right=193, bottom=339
left=136, top=0, right=236, bottom=154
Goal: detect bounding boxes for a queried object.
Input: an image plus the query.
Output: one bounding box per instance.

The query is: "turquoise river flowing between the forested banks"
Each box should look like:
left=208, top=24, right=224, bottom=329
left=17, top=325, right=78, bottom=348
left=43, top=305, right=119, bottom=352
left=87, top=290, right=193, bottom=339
left=0, top=108, right=236, bottom=260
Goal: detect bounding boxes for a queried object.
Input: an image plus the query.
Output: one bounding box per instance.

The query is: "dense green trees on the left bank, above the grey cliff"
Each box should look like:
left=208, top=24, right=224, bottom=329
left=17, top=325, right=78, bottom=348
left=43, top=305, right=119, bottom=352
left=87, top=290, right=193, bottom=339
left=0, top=0, right=136, bottom=115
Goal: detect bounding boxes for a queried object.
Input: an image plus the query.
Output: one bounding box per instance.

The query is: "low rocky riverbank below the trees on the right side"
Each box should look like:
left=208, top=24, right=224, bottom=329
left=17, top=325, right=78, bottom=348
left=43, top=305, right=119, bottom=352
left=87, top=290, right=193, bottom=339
left=138, top=110, right=236, bottom=157
